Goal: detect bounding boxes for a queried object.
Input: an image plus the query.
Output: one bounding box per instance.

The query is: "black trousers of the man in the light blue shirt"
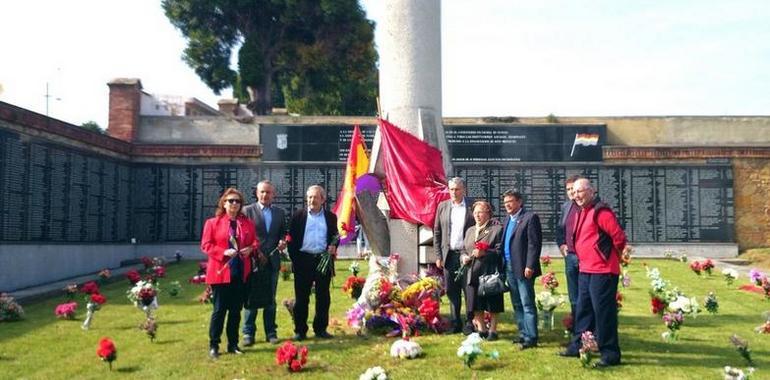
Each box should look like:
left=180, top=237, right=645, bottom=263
left=292, top=251, right=334, bottom=336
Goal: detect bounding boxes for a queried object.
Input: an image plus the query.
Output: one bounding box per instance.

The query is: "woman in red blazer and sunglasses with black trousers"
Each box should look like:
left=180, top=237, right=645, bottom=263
left=201, top=187, right=258, bottom=359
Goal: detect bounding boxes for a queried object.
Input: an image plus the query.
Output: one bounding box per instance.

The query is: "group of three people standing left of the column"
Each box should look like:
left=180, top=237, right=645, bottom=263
left=201, top=180, right=338, bottom=359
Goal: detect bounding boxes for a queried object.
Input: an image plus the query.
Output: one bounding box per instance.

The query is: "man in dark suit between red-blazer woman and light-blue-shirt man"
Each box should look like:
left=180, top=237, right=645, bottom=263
left=243, top=180, right=286, bottom=346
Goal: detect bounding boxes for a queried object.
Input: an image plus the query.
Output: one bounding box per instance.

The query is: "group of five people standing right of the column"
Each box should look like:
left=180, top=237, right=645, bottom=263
left=433, top=176, right=630, bottom=367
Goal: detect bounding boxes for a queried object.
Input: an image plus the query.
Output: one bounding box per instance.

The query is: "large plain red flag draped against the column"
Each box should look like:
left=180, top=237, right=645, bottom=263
left=377, top=119, right=449, bottom=228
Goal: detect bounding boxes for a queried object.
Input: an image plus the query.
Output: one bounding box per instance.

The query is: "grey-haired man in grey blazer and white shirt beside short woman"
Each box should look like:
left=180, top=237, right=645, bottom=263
left=433, top=177, right=475, bottom=334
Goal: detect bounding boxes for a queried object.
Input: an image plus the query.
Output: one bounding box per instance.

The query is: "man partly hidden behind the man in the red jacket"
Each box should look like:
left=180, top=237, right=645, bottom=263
left=555, top=175, right=580, bottom=326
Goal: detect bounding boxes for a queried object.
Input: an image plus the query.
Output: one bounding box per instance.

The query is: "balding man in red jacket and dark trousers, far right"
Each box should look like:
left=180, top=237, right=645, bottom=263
left=560, top=178, right=631, bottom=367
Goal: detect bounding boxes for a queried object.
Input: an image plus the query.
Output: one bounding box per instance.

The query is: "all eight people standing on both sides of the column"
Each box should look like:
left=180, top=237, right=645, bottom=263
left=195, top=176, right=630, bottom=366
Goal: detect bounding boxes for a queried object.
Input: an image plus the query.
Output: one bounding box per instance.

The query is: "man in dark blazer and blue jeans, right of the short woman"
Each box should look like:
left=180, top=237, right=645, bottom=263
left=502, top=190, right=543, bottom=350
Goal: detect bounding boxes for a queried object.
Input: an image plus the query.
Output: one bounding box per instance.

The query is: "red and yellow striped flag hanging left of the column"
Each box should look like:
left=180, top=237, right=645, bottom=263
left=334, top=125, right=369, bottom=243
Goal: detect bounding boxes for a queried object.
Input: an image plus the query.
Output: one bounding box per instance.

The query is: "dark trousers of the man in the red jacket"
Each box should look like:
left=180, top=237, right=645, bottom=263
left=568, top=272, right=620, bottom=364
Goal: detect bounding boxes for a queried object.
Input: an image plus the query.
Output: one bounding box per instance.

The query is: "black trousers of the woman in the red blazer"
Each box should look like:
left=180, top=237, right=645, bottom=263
left=209, top=279, right=245, bottom=349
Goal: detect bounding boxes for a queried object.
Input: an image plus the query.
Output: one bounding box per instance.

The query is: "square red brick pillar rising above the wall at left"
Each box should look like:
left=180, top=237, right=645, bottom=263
left=107, top=78, right=142, bottom=142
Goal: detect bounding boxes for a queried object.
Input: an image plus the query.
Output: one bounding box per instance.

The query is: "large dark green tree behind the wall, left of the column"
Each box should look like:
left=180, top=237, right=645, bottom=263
left=162, top=0, right=378, bottom=115
